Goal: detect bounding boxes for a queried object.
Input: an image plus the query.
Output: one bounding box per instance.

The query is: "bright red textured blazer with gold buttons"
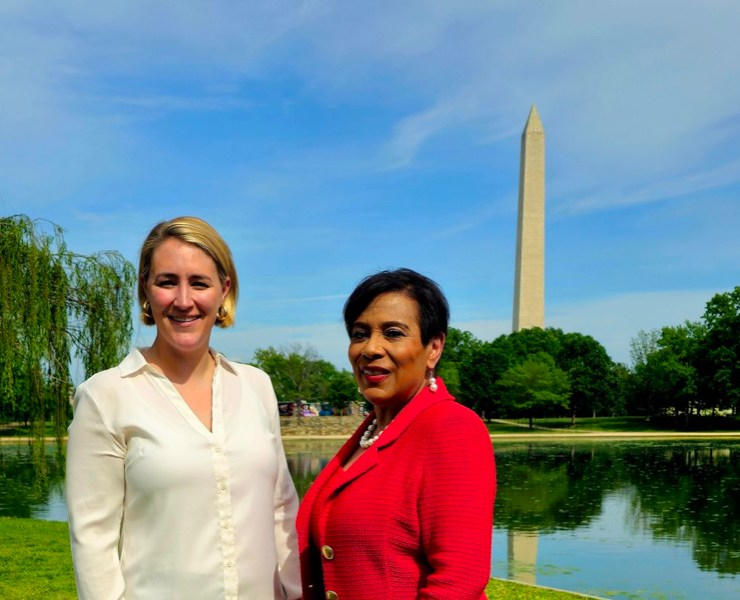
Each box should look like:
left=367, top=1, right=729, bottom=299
left=297, top=379, right=496, bottom=600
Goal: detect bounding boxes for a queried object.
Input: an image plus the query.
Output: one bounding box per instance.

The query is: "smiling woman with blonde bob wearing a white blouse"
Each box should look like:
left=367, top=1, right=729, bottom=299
left=67, top=217, right=301, bottom=600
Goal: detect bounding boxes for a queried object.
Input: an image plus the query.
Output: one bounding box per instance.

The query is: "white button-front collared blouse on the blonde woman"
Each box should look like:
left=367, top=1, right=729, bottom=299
left=67, top=350, right=301, bottom=600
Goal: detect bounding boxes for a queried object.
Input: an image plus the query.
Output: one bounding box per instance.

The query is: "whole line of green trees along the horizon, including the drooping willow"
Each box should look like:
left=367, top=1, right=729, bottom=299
left=0, top=215, right=740, bottom=437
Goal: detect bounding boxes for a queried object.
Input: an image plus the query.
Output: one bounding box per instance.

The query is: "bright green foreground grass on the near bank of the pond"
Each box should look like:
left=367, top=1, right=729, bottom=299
left=0, top=517, right=596, bottom=600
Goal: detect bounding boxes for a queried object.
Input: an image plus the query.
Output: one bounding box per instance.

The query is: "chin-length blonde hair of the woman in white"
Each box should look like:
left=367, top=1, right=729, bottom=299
left=138, top=217, right=239, bottom=327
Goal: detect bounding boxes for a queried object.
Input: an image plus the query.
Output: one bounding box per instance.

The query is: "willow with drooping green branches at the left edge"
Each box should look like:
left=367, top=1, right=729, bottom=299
left=0, top=215, right=135, bottom=438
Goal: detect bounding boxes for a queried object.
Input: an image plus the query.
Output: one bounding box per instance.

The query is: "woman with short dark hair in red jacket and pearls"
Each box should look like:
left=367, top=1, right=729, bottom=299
left=298, top=269, right=496, bottom=600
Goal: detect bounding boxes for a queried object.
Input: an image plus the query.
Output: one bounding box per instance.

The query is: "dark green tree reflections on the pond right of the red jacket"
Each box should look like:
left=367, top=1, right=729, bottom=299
left=496, top=441, right=740, bottom=575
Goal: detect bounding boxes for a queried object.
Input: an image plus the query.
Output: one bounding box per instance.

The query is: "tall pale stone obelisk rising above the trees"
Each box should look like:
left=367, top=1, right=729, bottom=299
left=512, top=105, right=545, bottom=331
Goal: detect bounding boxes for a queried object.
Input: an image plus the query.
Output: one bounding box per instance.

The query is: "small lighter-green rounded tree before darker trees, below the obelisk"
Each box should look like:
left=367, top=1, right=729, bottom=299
left=497, top=352, right=570, bottom=428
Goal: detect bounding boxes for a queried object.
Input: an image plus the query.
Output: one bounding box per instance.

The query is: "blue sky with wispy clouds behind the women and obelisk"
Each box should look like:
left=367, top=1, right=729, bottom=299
left=0, top=0, right=740, bottom=367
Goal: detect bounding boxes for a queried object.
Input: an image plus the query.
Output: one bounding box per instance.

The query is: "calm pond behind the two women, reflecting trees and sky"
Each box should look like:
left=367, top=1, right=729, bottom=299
left=0, top=439, right=740, bottom=600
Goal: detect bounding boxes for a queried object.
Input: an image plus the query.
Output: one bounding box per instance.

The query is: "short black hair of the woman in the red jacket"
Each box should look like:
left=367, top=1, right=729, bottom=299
left=344, top=269, right=450, bottom=346
